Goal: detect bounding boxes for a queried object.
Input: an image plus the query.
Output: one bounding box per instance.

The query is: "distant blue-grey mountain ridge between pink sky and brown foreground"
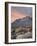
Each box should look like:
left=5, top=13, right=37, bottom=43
left=11, top=16, right=32, bottom=28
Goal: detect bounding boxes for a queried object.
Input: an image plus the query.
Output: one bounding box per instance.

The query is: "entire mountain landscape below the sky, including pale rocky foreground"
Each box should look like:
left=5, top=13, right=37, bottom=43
left=11, top=16, right=32, bottom=39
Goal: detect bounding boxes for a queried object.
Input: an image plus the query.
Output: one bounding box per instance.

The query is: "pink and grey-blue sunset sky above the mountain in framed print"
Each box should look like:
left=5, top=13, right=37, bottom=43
left=11, top=7, right=32, bottom=22
